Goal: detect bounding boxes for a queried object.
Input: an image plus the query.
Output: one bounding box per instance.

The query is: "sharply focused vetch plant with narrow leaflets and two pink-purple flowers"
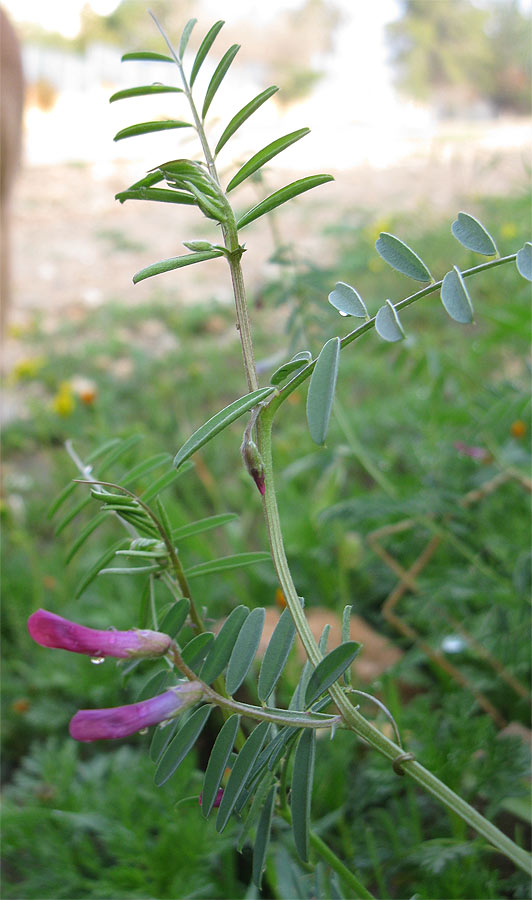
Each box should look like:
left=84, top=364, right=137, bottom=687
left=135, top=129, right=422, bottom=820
left=28, top=19, right=532, bottom=897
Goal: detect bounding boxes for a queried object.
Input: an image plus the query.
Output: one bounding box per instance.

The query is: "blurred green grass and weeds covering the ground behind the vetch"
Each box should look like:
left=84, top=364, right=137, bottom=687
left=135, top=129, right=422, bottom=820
left=2, top=197, right=530, bottom=900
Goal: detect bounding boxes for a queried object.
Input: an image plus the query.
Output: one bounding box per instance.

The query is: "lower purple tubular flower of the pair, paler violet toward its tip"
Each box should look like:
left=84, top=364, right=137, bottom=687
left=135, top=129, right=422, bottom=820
left=69, top=681, right=203, bottom=741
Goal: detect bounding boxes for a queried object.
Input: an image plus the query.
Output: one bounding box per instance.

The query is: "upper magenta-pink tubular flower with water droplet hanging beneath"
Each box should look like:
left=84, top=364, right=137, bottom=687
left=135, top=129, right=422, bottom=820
left=28, top=609, right=172, bottom=659
